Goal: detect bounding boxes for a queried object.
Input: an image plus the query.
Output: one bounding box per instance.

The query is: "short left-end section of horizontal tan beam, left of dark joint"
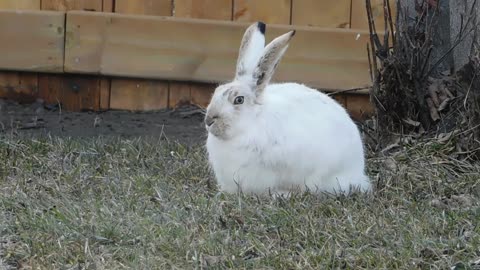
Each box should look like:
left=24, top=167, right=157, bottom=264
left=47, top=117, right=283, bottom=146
left=0, top=10, right=65, bottom=72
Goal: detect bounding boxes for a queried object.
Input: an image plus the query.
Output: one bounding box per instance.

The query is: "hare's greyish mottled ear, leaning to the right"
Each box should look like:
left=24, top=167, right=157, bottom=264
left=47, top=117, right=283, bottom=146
left=253, top=30, right=295, bottom=96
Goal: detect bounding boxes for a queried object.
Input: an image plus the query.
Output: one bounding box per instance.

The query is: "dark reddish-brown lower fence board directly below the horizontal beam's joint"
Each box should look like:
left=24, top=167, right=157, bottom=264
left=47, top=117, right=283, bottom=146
left=39, top=75, right=100, bottom=111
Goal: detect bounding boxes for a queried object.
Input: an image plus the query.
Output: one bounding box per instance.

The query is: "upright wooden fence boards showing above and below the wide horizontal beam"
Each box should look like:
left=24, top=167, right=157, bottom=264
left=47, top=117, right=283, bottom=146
left=0, top=0, right=394, bottom=118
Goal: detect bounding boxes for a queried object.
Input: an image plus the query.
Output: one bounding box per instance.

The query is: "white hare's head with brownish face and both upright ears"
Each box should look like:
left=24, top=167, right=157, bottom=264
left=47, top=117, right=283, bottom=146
left=205, top=22, right=295, bottom=140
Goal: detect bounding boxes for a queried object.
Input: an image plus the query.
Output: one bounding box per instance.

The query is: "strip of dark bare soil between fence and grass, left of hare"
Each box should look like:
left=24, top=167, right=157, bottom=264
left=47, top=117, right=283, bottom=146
left=0, top=99, right=206, bottom=145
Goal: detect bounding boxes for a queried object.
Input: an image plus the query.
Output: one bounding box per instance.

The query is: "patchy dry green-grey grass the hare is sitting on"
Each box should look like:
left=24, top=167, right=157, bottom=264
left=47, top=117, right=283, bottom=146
left=0, top=138, right=480, bottom=269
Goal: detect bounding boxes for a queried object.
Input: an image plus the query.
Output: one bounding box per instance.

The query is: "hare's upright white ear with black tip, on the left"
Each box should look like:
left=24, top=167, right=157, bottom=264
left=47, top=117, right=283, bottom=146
left=235, top=22, right=265, bottom=80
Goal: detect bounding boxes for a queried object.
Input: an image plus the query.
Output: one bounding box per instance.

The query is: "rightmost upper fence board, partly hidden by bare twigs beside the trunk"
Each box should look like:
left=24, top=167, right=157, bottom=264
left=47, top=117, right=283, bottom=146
left=351, top=0, right=397, bottom=32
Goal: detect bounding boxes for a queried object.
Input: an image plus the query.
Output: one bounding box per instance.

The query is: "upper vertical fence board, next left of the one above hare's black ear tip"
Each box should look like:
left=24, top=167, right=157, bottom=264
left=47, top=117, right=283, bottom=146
left=173, top=0, right=232, bottom=21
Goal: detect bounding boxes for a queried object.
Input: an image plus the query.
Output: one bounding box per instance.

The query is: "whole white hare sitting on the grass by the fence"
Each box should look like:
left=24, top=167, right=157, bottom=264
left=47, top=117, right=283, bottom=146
left=205, top=22, right=370, bottom=193
